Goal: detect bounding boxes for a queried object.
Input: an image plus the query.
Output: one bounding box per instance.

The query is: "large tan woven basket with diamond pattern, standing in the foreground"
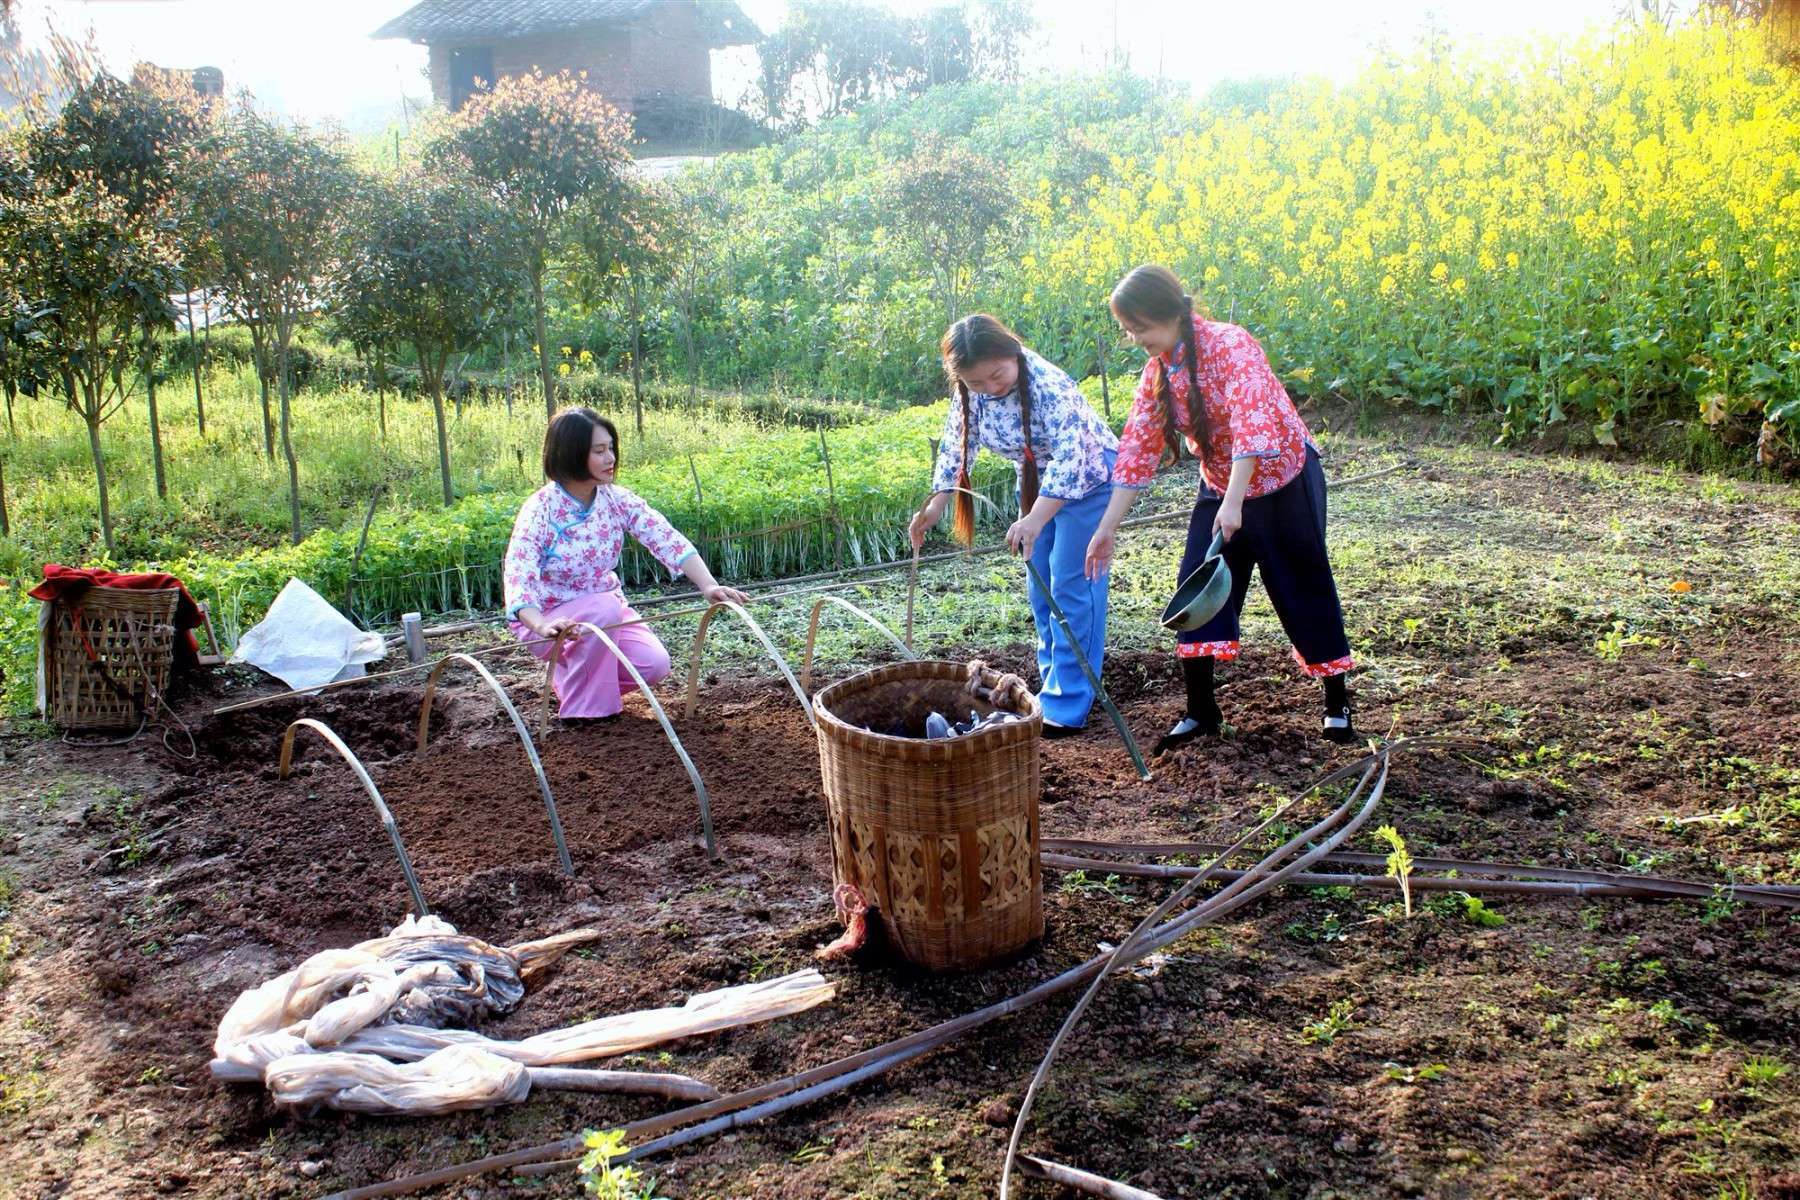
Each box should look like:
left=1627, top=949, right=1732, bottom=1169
left=812, top=662, right=1044, bottom=970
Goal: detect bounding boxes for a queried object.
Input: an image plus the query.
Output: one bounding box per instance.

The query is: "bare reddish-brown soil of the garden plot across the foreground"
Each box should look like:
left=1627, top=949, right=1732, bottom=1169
left=0, top=631, right=1800, bottom=1200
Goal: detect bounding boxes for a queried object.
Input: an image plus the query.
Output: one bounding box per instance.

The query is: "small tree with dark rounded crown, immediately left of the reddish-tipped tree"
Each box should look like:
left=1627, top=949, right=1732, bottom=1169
left=340, top=175, right=520, bottom=506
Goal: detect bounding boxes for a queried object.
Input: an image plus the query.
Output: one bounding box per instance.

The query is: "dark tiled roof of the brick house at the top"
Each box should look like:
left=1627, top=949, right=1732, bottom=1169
left=374, top=0, right=760, bottom=47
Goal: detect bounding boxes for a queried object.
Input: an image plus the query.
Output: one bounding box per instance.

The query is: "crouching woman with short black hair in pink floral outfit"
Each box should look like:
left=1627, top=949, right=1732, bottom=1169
left=506, top=408, right=749, bottom=718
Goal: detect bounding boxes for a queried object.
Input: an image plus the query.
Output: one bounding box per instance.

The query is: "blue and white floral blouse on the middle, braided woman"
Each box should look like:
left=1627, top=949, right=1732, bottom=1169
left=931, top=349, right=1120, bottom=500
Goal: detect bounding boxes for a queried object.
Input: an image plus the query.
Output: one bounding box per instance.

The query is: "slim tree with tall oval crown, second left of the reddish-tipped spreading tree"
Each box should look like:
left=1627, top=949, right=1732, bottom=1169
left=196, top=101, right=355, bottom=542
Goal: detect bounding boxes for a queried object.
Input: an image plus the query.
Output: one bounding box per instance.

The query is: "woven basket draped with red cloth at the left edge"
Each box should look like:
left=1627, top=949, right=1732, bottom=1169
left=43, top=587, right=182, bottom=729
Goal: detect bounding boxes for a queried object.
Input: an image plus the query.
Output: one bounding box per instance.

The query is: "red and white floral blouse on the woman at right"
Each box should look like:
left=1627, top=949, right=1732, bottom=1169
left=1112, top=317, right=1312, bottom=498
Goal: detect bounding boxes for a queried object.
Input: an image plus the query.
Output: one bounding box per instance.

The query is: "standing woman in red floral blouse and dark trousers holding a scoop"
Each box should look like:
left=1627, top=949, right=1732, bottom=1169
left=1087, top=264, right=1357, bottom=752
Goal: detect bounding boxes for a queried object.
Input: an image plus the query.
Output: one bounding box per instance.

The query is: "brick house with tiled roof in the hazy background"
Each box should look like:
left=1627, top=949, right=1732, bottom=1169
left=374, top=0, right=760, bottom=113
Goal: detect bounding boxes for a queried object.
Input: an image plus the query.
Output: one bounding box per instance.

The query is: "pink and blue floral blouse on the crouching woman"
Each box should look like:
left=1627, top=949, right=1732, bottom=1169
left=504, top=482, right=693, bottom=619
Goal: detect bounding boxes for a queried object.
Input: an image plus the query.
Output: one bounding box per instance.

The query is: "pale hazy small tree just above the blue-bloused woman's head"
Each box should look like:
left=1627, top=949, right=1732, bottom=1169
left=887, top=144, right=1019, bottom=326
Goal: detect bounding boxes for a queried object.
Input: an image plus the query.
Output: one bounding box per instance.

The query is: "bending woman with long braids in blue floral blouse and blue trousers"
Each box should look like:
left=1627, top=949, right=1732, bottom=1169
left=909, top=313, right=1118, bottom=738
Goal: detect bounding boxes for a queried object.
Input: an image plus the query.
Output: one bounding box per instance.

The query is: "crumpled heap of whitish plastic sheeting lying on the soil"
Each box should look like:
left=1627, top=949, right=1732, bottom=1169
left=212, top=916, right=835, bottom=1115
